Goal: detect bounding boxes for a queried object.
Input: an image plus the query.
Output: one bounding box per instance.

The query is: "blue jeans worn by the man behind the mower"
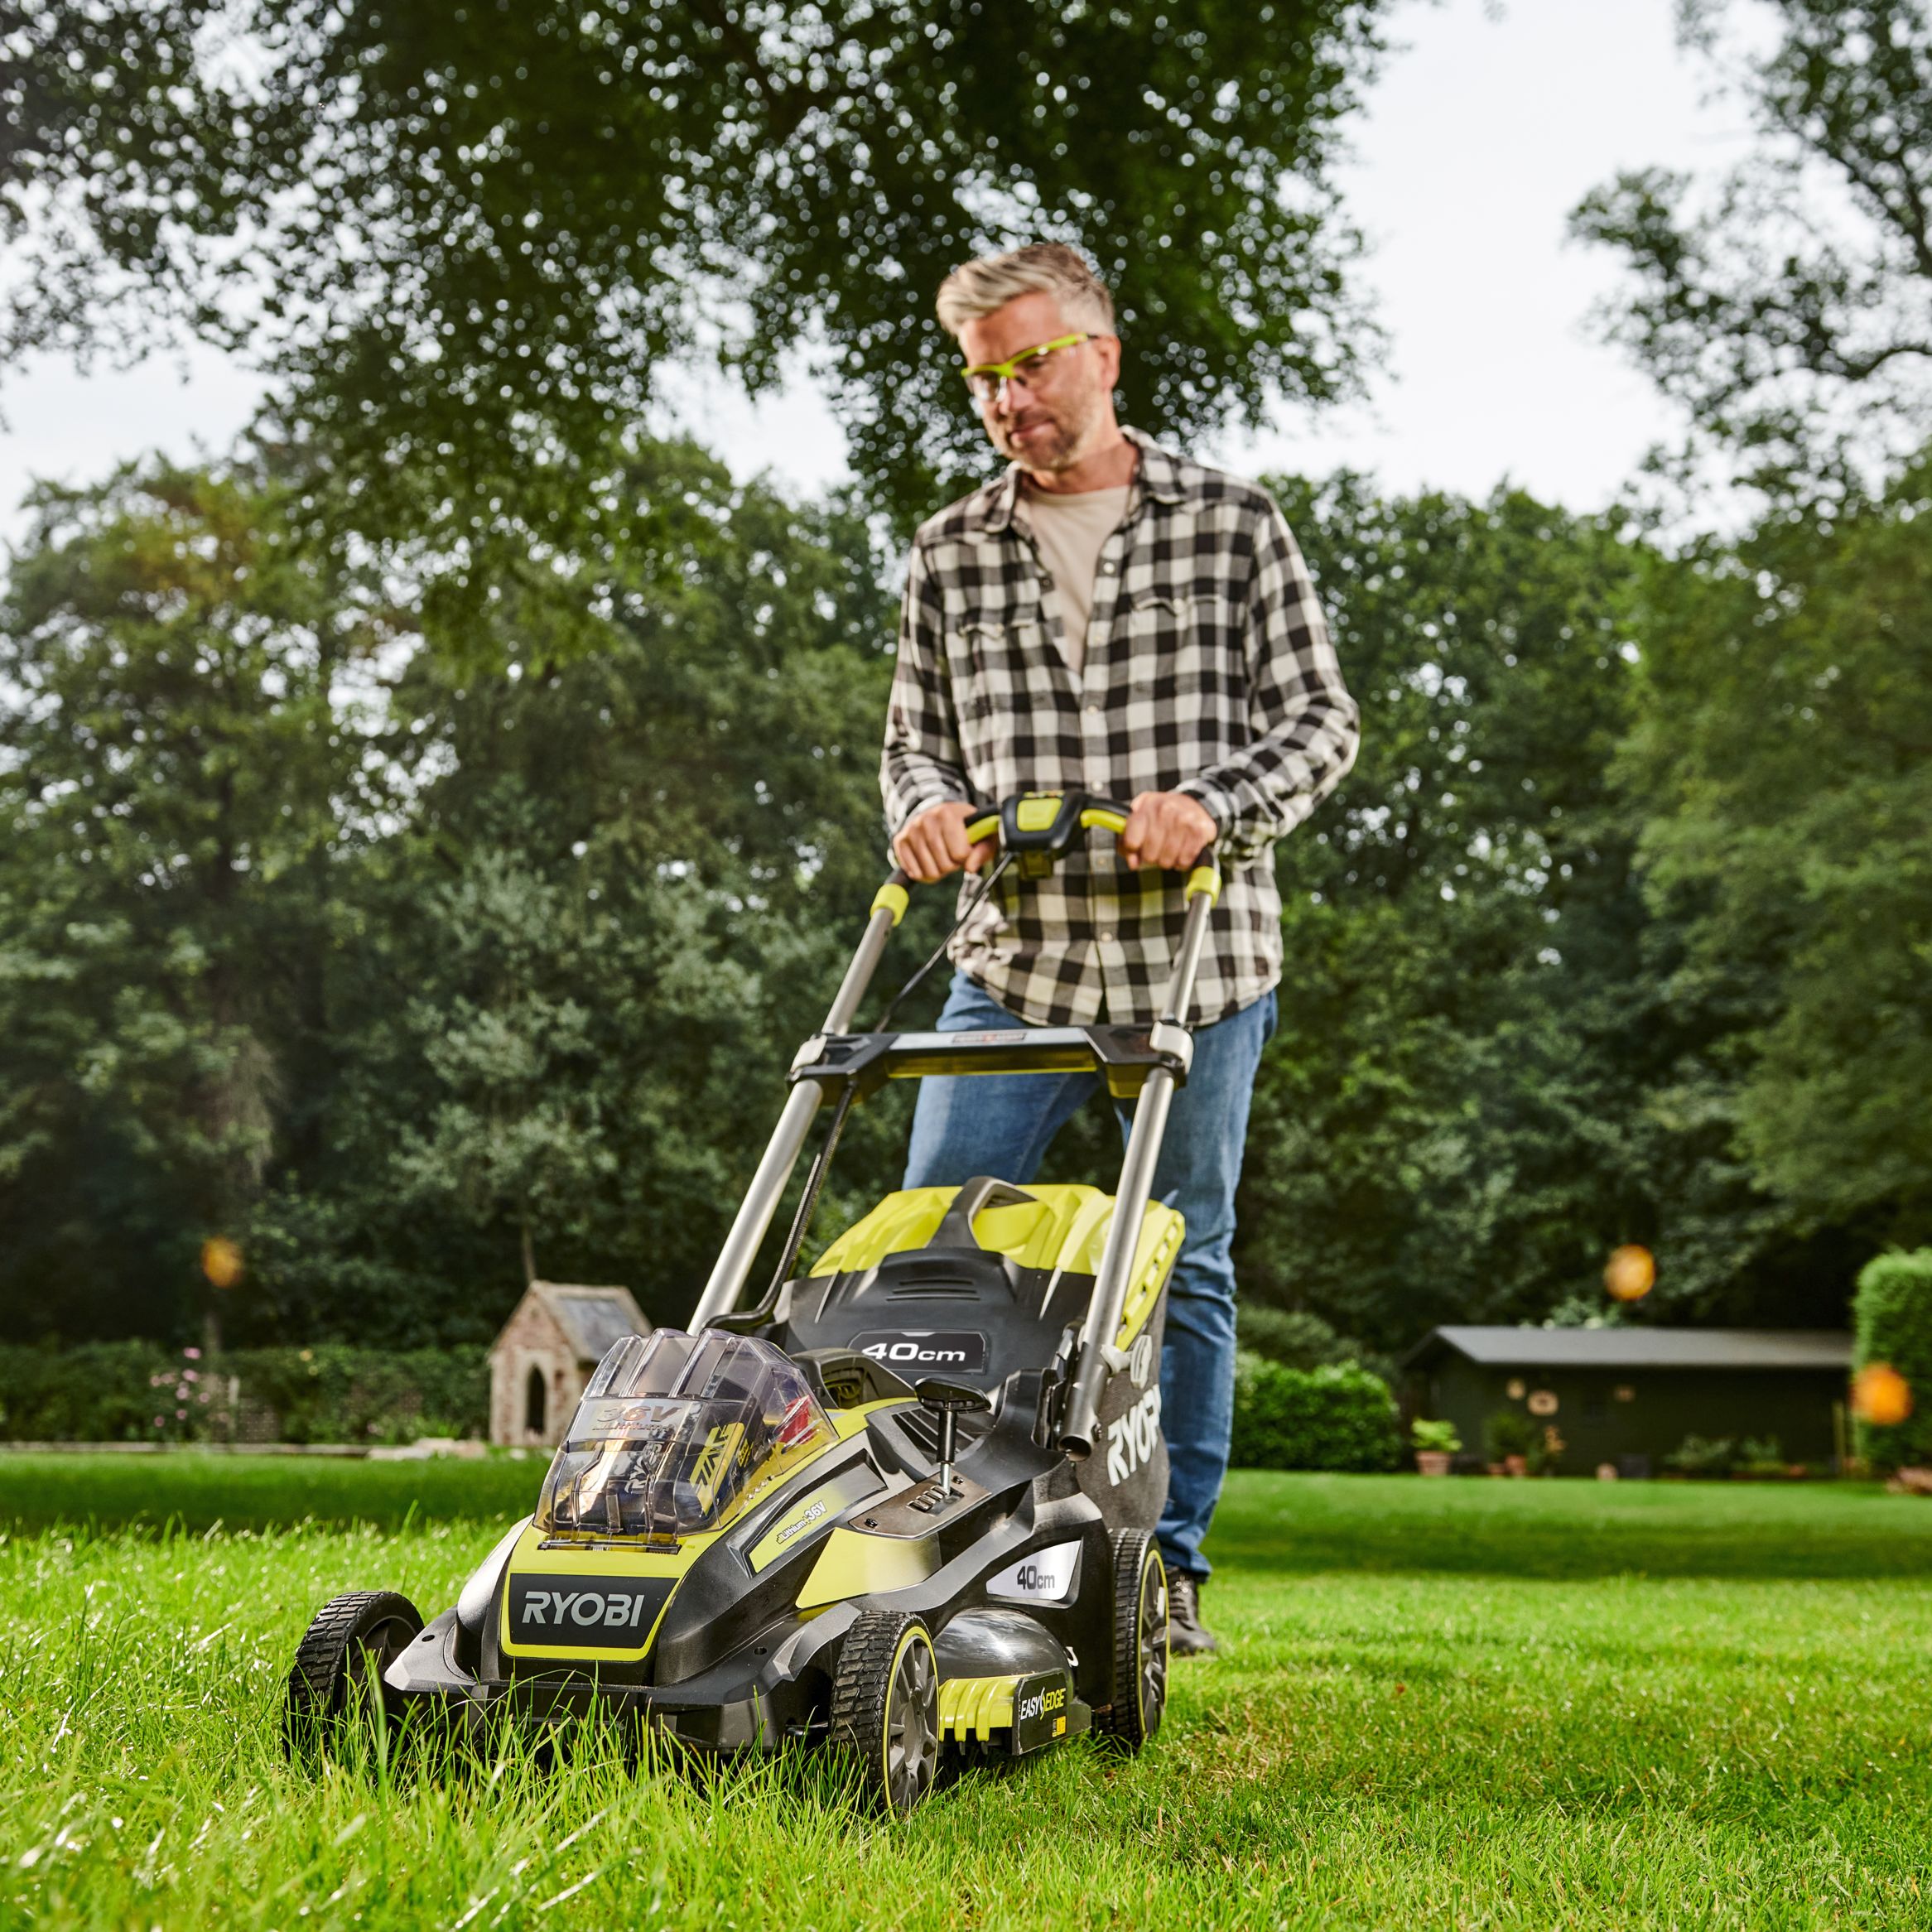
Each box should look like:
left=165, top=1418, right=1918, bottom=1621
left=906, top=974, right=1275, bottom=1577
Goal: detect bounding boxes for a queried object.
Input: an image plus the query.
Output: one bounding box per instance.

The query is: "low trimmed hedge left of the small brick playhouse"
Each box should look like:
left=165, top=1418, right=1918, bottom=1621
left=0, top=1341, right=489, bottom=1443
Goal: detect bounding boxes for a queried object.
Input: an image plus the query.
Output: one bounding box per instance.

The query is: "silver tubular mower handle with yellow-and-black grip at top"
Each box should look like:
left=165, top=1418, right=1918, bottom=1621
left=691, top=793, right=1221, bottom=1458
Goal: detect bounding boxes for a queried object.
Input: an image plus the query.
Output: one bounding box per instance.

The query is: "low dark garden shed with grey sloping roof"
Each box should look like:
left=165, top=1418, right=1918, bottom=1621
left=1403, top=1327, right=1851, bottom=1474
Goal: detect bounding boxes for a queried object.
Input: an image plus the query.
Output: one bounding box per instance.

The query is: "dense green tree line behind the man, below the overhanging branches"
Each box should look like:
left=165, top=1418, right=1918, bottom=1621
left=0, top=445, right=1932, bottom=1370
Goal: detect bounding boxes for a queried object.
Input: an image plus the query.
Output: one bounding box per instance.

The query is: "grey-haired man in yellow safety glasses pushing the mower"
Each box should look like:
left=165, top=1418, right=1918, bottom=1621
left=881, top=243, right=1356, bottom=1654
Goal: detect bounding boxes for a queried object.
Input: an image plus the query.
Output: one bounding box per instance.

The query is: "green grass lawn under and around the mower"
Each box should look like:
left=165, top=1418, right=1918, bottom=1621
left=0, top=1458, right=1932, bottom=1932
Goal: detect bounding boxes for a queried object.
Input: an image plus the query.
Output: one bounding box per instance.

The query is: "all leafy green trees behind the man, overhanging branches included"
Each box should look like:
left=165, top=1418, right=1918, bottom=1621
left=0, top=0, right=1932, bottom=1356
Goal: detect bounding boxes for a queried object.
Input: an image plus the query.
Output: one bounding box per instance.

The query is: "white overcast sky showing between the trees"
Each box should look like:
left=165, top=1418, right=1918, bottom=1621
left=0, top=0, right=1747, bottom=537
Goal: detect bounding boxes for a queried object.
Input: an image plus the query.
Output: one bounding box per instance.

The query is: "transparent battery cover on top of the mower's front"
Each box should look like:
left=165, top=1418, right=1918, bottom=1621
left=537, top=1329, right=835, bottom=1538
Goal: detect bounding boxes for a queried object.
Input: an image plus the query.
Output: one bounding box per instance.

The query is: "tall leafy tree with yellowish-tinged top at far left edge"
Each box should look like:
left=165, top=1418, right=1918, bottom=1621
left=0, top=468, right=384, bottom=1333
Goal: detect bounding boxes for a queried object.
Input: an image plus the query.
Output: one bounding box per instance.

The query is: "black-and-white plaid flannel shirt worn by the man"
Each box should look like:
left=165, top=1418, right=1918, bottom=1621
left=879, top=429, right=1358, bottom=1026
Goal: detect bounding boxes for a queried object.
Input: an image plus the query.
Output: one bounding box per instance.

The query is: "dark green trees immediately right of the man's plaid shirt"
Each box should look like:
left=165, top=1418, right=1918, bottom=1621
left=1238, top=477, right=1679, bottom=1351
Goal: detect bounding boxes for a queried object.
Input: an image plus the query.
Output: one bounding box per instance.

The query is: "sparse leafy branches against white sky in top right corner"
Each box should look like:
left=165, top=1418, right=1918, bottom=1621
left=1573, top=0, right=1932, bottom=497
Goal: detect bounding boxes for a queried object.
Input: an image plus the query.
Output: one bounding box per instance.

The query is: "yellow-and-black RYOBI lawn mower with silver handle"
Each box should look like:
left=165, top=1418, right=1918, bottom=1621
left=284, top=794, right=1221, bottom=1816
